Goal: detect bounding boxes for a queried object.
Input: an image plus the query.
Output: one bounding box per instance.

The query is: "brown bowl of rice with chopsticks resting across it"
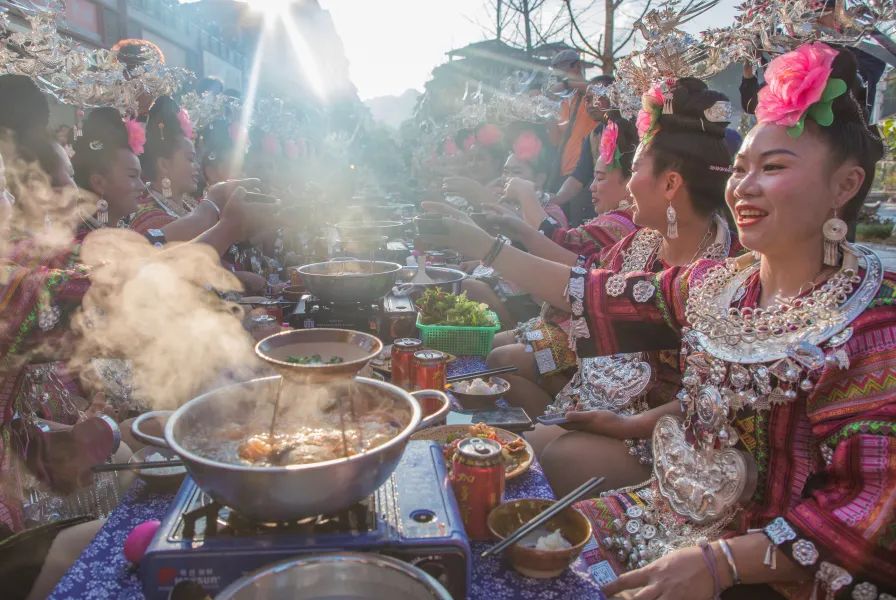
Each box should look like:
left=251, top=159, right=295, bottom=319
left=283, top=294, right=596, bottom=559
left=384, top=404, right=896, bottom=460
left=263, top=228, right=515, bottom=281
left=488, top=498, right=591, bottom=579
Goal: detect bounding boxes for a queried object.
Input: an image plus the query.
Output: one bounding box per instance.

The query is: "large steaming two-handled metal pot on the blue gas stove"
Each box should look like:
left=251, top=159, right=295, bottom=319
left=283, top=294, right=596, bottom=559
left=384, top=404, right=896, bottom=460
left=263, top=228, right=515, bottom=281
left=165, top=377, right=421, bottom=522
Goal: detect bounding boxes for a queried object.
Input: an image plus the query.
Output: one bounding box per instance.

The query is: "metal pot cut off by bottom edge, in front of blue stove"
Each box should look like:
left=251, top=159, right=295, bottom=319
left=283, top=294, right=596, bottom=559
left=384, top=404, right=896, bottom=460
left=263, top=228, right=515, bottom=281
left=216, top=552, right=451, bottom=600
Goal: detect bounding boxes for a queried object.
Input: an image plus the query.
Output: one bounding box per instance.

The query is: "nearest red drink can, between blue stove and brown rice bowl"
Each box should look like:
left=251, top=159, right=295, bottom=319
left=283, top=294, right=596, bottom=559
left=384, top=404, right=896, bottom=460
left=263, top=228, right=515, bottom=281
left=451, top=437, right=504, bottom=540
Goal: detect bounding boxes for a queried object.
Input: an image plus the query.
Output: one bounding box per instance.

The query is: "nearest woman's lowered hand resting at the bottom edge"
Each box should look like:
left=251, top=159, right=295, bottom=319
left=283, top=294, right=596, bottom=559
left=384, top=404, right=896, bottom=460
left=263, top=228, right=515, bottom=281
left=601, top=546, right=731, bottom=600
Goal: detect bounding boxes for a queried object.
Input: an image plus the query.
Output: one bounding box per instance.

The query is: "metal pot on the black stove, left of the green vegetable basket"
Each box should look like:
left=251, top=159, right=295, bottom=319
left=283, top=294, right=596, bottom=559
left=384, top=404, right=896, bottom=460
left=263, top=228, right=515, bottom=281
left=299, top=260, right=401, bottom=302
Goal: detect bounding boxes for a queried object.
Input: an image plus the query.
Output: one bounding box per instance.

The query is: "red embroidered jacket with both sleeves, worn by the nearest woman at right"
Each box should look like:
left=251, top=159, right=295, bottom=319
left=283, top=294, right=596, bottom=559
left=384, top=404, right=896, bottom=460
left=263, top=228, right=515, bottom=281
left=571, top=261, right=896, bottom=598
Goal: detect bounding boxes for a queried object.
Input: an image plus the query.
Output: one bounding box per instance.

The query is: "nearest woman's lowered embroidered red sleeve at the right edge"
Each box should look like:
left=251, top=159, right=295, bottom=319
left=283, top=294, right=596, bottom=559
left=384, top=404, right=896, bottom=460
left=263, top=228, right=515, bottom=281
left=766, top=303, right=896, bottom=600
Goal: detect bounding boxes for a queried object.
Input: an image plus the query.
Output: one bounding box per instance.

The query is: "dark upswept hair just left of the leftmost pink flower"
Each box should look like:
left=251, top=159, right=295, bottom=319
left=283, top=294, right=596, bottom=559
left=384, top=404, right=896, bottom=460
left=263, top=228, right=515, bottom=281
left=72, top=108, right=131, bottom=190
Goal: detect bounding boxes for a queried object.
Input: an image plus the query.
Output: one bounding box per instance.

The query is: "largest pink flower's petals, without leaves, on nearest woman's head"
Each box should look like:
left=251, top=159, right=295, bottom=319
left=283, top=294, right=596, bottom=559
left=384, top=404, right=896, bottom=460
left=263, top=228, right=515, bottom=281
left=756, top=42, right=837, bottom=127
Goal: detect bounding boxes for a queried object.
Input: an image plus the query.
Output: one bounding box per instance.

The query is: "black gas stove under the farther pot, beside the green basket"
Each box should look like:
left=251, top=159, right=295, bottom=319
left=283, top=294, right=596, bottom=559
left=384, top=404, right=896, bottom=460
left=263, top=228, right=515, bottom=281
left=289, top=294, right=417, bottom=344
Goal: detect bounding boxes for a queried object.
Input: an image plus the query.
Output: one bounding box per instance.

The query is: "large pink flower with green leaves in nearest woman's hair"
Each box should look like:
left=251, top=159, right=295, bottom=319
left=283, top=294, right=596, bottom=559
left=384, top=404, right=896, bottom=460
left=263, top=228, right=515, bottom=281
left=756, top=42, right=847, bottom=137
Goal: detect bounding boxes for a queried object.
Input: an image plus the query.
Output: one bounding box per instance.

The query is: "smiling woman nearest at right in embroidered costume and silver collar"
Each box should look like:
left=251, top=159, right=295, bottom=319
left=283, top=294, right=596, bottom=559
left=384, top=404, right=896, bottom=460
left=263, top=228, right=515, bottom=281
left=428, top=43, right=896, bottom=599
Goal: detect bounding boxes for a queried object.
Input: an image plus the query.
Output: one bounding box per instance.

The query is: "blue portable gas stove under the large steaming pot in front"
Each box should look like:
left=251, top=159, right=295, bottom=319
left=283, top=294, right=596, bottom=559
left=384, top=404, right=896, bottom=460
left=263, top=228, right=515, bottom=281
left=140, top=441, right=471, bottom=600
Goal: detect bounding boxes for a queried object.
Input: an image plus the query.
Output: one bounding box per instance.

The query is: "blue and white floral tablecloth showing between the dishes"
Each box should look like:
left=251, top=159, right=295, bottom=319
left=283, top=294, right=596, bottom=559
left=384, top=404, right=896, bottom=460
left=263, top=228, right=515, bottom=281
left=50, top=358, right=602, bottom=600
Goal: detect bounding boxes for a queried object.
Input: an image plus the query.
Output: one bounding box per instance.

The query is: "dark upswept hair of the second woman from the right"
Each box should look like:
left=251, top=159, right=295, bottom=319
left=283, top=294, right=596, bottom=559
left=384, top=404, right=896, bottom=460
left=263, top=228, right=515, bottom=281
left=648, top=77, right=731, bottom=215
